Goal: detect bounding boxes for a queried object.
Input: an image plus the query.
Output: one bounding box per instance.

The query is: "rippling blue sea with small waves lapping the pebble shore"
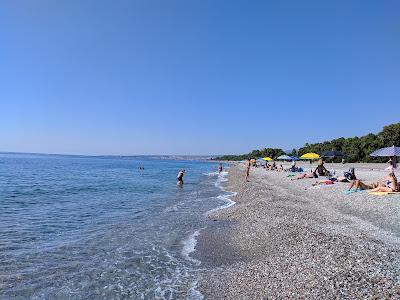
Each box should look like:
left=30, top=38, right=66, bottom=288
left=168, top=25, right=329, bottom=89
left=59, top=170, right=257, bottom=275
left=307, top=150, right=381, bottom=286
left=0, top=154, right=230, bottom=299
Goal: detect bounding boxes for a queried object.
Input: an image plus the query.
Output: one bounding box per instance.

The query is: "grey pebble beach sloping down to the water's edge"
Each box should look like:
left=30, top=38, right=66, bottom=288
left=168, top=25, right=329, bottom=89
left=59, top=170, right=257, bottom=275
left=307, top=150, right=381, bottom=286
left=195, top=164, right=400, bottom=299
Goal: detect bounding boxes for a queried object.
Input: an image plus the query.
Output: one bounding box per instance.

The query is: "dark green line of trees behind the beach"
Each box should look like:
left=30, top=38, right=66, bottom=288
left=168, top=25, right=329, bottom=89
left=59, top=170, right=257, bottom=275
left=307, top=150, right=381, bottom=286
left=215, top=123, right=400, bottom=162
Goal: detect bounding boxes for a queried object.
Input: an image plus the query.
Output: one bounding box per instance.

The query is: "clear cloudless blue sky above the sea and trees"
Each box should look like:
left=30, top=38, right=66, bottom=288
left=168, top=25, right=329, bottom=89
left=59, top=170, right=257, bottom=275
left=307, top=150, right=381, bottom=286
left=0, top=0, right=400, bottom=155
